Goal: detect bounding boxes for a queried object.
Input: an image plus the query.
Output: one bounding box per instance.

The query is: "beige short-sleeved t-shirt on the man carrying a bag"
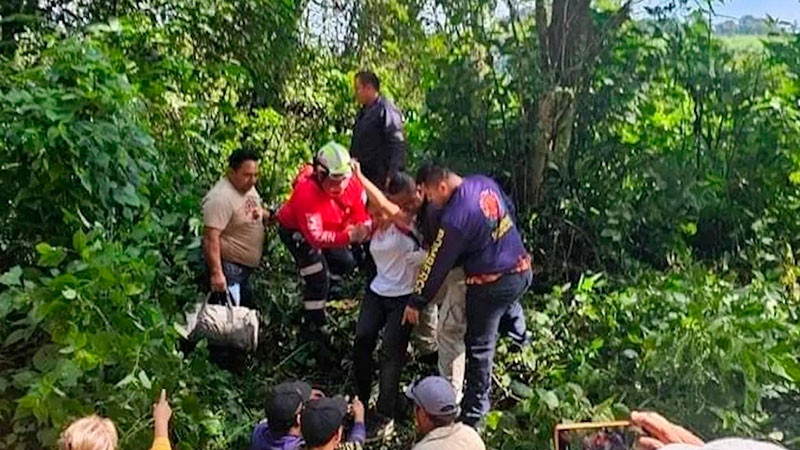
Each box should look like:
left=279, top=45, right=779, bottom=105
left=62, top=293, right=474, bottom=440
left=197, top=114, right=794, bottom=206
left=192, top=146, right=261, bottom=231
left=203, top=177, right=264, bottom=267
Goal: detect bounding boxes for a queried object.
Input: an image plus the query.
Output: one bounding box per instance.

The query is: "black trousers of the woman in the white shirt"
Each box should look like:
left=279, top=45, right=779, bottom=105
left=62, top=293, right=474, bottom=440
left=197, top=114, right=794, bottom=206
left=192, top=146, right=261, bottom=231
left=353, top=288, right=411, bottom=418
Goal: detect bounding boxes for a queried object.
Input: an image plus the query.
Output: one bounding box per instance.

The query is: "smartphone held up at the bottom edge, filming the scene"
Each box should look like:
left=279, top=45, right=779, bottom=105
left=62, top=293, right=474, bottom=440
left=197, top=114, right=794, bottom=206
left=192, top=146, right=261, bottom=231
left=553, top=420, right=642, bottom=450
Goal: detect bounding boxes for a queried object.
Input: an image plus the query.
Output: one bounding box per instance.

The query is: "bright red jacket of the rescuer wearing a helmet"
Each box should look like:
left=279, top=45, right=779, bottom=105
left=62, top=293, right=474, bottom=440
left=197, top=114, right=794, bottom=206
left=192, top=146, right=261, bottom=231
left=278, top=165, right=371, bottom=248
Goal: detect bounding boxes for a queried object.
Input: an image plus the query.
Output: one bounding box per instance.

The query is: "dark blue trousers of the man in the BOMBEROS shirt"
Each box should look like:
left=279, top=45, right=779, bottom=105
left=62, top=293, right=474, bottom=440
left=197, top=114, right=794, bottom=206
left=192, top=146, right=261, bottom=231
left=461, top=271, right=532, bottom=427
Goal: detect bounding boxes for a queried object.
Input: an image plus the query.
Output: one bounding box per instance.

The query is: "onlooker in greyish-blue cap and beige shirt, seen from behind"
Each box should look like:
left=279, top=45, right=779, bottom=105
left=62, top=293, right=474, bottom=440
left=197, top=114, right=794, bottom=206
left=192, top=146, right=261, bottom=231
left=406, top=376, right=486, bottom=450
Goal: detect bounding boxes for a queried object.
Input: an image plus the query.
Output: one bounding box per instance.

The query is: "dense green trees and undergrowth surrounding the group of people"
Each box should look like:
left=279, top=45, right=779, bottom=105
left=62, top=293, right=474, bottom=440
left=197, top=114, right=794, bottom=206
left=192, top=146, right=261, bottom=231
left=0, top=0, right=800, bottom=449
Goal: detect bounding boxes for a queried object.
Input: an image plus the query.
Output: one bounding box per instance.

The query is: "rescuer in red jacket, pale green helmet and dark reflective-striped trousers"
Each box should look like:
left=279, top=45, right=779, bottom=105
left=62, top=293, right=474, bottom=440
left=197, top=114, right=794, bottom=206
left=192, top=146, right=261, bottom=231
left=277, top=142, right=372, bottom=351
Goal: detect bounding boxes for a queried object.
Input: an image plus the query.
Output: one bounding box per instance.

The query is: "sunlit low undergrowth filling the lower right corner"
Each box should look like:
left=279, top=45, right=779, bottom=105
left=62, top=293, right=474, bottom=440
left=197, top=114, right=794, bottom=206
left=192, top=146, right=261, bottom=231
left=489, top=267, right=800, bottom=448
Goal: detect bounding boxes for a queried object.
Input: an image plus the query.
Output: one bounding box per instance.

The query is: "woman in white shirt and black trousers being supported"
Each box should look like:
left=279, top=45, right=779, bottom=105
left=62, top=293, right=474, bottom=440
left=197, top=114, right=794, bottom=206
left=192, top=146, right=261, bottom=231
left=353, top=173, right=427, bottom=438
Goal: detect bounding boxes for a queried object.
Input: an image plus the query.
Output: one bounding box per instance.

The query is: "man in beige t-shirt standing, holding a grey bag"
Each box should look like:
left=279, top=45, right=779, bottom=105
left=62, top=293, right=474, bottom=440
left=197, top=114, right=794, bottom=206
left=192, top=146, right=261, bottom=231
left=203, top=149, right=269, bottom=307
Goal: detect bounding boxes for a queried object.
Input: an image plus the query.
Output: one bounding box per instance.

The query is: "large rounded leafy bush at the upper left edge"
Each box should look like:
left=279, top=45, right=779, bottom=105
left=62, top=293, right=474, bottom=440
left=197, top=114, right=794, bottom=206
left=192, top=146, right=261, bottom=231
left=0, top=33, right=160, bottom=260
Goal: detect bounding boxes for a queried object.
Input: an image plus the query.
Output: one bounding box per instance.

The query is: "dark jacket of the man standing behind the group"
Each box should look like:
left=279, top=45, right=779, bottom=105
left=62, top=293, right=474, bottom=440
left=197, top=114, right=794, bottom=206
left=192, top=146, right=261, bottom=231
left=350, top=97, right=407, bottom=189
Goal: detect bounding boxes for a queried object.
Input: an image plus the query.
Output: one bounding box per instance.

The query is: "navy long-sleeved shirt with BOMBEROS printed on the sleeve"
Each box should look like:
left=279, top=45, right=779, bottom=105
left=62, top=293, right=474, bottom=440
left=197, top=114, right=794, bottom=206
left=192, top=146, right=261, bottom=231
left=414, top=175, right=527, bottom=307
